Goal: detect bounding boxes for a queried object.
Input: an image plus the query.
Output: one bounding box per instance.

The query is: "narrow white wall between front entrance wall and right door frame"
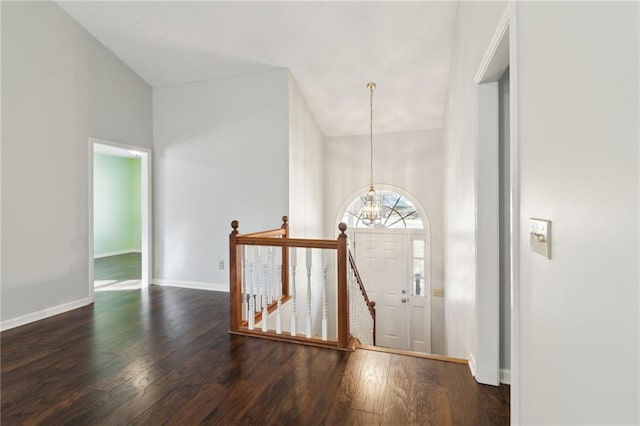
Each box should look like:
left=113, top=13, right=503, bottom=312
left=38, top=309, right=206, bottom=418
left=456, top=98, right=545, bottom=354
left=444, top=2, right=505, bottom=358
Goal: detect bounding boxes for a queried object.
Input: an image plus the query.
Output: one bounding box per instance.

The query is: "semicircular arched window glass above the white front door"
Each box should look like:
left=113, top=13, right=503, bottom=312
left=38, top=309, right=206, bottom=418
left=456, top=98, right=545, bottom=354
left=342, top=189, right=424, bottom=229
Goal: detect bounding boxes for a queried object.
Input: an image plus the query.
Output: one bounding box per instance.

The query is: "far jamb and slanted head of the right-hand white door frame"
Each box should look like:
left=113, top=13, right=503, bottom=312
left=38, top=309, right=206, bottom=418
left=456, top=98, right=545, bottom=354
left=472, top=3, right=517, bottom=386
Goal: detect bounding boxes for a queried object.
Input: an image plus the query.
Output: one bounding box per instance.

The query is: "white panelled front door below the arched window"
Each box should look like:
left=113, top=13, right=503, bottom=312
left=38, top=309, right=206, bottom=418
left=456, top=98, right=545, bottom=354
left=353, top=230, right=431, bottom=352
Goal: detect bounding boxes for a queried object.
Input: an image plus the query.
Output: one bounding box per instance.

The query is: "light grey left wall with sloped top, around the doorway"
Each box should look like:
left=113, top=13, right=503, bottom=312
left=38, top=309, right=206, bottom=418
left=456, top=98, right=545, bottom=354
left=0, top=2, right=152, bottom=328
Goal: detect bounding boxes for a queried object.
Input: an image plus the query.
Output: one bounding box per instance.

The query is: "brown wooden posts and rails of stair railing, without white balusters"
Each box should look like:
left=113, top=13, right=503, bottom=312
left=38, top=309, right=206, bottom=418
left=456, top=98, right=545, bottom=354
left=229, top=216, right=355, bottom=350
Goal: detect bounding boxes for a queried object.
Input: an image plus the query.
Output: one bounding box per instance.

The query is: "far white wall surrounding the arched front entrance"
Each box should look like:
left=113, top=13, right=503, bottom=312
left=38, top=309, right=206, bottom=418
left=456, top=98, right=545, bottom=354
left=324, top=129, right=446, bottom=353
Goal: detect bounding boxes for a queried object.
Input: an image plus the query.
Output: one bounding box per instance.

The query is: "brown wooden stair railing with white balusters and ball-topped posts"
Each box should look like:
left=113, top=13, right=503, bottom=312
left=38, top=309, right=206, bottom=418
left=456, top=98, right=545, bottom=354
left=229, top=216, right=356, bottom=350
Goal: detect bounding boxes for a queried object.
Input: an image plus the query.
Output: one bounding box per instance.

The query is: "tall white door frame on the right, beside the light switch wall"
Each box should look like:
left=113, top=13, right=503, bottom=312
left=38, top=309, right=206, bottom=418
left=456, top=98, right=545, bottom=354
left=470, top=2, right=520, bottom=412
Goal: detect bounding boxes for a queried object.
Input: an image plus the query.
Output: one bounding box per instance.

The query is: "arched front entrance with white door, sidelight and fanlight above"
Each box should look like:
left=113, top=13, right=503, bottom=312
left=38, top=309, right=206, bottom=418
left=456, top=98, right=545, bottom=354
left=340, top=187, right=432, bottom=353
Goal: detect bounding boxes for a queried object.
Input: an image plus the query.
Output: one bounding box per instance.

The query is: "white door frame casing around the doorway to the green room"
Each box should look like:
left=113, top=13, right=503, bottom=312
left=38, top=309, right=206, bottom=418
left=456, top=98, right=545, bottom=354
left=88, top=137, right=153, bottom=303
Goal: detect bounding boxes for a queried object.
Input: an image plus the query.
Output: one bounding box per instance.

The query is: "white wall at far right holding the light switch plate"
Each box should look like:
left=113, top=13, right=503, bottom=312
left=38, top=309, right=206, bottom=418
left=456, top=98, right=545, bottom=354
left=512, top=2, right=640, bottom=425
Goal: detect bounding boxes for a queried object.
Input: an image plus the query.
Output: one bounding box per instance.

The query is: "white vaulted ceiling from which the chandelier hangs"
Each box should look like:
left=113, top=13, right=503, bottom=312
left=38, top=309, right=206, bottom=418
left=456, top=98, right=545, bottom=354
left=59, top=2, right=456, bottom=136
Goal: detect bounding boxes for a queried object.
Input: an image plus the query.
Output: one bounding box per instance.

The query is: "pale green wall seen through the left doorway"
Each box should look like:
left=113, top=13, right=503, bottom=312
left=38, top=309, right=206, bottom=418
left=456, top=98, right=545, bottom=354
left=93, top=154, right=142, bottom=255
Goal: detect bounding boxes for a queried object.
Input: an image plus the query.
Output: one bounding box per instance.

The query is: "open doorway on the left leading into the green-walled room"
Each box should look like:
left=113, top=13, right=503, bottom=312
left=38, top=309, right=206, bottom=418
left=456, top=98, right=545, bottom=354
left=89, top=138, right=151, bottom=300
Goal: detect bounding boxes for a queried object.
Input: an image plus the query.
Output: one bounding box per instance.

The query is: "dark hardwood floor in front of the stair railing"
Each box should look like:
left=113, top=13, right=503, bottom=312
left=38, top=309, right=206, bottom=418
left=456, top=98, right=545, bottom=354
left=0, top=286, right=509, bottom=426
